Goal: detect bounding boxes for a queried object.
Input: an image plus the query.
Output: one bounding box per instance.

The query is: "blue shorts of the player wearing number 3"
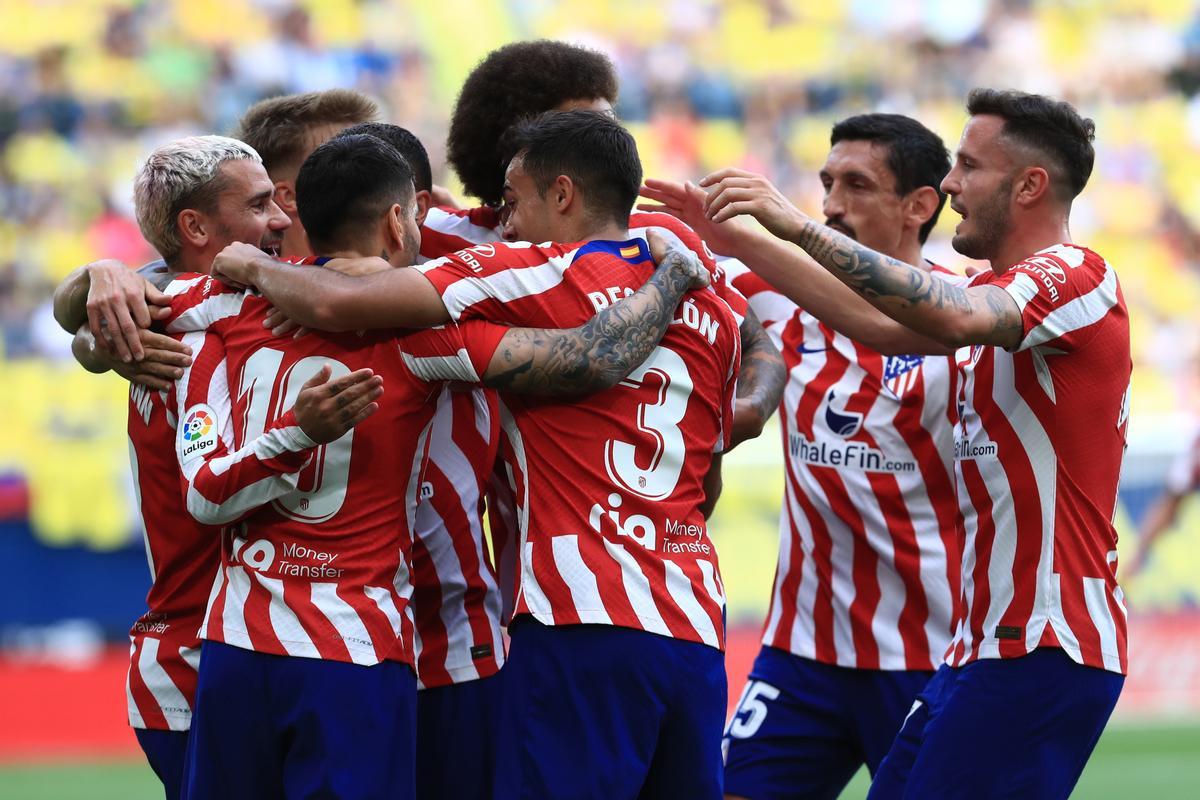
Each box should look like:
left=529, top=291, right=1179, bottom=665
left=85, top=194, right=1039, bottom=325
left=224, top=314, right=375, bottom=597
left=494, top=616, right=726, bottom=800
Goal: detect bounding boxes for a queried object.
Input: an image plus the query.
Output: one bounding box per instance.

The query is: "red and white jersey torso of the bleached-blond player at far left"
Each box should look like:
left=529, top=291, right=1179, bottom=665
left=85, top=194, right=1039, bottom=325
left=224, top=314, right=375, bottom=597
left=126, top=371, right=220, bottom=730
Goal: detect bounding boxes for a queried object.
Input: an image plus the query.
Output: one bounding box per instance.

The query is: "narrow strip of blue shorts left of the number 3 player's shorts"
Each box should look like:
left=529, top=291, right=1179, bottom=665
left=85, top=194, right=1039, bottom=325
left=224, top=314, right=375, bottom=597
left=416, top=668, right=505, bottom=800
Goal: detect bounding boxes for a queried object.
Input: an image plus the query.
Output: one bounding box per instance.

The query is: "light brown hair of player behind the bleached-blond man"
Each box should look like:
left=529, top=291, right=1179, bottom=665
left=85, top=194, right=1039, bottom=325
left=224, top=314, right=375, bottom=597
left=233, top=89, right=379, bottom=180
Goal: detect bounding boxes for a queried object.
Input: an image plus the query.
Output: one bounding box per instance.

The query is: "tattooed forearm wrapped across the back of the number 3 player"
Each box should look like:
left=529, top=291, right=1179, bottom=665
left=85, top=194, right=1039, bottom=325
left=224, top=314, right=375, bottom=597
left=484, top=251, right=703, bottom=395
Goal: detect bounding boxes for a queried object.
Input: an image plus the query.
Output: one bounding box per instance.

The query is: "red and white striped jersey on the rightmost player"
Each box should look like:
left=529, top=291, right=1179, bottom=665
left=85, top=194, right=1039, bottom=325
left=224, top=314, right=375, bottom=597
left=947, top=245, right=1132, bottom=673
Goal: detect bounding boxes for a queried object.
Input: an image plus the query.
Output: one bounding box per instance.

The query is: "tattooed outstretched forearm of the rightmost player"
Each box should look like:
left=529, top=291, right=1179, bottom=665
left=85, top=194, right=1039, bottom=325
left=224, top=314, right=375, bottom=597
left=794, top=219, right=1021, bottom=347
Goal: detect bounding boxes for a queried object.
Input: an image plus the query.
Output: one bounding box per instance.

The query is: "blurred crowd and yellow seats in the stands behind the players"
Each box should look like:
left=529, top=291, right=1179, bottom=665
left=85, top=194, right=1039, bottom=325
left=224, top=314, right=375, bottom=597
left=0, top=0, right=1200, bottom=544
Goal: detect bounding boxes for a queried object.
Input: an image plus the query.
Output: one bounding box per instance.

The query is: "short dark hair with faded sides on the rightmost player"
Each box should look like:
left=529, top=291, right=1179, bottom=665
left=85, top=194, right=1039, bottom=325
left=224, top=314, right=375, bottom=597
left=967, top=88, right=1096, bottom=203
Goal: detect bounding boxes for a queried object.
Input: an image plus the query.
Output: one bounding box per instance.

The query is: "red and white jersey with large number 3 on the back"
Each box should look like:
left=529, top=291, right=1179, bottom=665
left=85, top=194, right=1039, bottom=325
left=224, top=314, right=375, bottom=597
left=418, top=232, right=744, bottom=648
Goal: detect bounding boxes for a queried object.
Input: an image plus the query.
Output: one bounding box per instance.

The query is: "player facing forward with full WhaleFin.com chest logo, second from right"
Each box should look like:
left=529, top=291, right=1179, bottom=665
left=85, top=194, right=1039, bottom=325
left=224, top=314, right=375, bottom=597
left=641, top=114, right=961, bottom=800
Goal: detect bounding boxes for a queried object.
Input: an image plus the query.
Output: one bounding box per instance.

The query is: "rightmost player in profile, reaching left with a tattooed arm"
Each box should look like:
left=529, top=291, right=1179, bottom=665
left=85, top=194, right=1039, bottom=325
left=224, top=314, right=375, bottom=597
left=701, top=89, right=1130, bottom=798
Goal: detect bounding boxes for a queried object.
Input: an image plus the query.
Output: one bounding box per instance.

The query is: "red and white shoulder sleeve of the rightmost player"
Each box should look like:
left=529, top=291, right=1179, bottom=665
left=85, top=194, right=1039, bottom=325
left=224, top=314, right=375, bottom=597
left=970, top=245, right=1121, bottom=351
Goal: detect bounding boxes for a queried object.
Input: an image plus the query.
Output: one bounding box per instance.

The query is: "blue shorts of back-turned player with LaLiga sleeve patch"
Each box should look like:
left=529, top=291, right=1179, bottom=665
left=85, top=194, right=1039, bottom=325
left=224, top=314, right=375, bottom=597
left=185, top=642, right=416, bottom=800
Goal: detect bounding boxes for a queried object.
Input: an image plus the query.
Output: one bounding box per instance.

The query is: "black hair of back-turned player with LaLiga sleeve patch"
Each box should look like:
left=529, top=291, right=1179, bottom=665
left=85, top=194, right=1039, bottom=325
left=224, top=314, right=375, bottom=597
left=296, top=136, right=413, bottom=253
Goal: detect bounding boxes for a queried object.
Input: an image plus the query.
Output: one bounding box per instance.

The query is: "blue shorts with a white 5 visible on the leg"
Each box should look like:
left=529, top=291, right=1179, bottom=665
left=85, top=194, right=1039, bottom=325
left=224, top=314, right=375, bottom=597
left=724, top=646, right=934, bottom=800
